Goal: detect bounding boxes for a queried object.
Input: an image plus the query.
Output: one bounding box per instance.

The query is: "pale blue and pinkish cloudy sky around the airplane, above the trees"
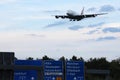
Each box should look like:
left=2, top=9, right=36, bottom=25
left=0, top=0, right=120, bottom=60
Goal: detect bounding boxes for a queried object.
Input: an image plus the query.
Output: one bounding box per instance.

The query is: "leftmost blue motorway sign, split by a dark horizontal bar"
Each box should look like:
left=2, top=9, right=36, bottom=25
left=14, top=60, right=42, bottom=80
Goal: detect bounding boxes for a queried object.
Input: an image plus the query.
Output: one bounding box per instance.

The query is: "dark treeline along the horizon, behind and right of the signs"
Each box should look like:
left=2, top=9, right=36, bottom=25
left=15, top=55, right=120, bottom=80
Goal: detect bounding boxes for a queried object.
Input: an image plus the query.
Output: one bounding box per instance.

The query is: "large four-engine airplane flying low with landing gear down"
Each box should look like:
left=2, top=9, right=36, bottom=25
left=55, top=8, right=107, bottom=21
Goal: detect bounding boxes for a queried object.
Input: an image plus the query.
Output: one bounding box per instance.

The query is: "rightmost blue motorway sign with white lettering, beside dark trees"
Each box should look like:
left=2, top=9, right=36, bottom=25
left=66, top=61, right=84, bottom=80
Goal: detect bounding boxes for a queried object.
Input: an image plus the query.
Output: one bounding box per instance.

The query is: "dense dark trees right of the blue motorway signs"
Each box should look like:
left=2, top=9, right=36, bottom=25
left=85, top=57, right=120, bottom=80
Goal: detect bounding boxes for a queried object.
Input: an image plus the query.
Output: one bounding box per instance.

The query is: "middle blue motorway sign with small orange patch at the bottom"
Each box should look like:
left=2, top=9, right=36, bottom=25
left=44, top=60, right=63, bottom=80
